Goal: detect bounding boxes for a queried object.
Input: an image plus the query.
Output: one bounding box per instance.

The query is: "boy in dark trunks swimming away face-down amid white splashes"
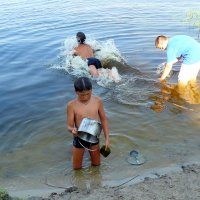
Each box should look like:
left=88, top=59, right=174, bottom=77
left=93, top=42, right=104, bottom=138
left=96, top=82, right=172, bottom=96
left=73, top=32, right=119, bottom=81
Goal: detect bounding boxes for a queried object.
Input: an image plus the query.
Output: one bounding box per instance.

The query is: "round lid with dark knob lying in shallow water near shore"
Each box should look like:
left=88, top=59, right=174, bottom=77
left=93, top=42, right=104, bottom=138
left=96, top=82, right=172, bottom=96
left=127, top=150, right=146, bottom=165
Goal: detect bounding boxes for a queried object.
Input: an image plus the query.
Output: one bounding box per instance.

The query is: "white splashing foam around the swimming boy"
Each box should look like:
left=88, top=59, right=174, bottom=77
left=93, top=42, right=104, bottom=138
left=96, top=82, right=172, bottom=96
left=51, top=36, right=125, bottom=87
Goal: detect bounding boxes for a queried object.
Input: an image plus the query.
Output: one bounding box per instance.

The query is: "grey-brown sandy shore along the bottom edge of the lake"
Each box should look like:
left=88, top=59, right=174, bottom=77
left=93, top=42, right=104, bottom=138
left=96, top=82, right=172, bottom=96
left=8, top=164, right=200, bottom=200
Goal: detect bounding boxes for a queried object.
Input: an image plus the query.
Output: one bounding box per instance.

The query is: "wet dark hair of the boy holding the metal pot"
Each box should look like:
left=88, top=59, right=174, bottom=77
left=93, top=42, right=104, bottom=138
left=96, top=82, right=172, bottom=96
left=74, top=77, right=92, bottom=92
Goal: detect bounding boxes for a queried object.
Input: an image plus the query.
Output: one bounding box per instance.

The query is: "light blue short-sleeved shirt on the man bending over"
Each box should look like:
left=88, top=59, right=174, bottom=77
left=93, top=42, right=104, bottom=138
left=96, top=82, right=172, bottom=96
left=167, top=35, right=200, bottom=65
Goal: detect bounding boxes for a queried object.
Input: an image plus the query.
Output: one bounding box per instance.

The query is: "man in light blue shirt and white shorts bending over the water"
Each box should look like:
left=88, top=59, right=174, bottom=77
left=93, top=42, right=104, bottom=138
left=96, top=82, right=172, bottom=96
left=155, top=35, right=200, bottom=85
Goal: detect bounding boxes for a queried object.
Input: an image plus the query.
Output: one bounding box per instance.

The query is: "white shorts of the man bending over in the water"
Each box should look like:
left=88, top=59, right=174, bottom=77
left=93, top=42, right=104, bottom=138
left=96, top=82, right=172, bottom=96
left=178, top=62, right=200, bottom=83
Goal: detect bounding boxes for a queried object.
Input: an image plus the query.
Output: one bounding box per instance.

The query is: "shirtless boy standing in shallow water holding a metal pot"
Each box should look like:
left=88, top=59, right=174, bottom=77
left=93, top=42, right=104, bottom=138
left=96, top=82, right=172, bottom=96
left=67, top=77, right=110, bottom=169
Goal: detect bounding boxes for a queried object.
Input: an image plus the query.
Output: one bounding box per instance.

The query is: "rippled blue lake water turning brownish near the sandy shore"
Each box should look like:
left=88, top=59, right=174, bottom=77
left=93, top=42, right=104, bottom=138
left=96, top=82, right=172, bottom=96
left=0, top=0, right=200, bottom=197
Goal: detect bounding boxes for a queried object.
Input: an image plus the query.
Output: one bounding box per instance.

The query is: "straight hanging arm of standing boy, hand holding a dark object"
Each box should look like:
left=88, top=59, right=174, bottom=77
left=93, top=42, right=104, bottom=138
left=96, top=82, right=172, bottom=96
left=99, top=99, right=110, bottom=149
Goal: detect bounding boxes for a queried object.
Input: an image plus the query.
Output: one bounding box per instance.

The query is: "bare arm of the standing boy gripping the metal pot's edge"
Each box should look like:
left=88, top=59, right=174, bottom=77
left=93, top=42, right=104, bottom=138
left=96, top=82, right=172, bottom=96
left=67, top=102, right=78, bottom=136
